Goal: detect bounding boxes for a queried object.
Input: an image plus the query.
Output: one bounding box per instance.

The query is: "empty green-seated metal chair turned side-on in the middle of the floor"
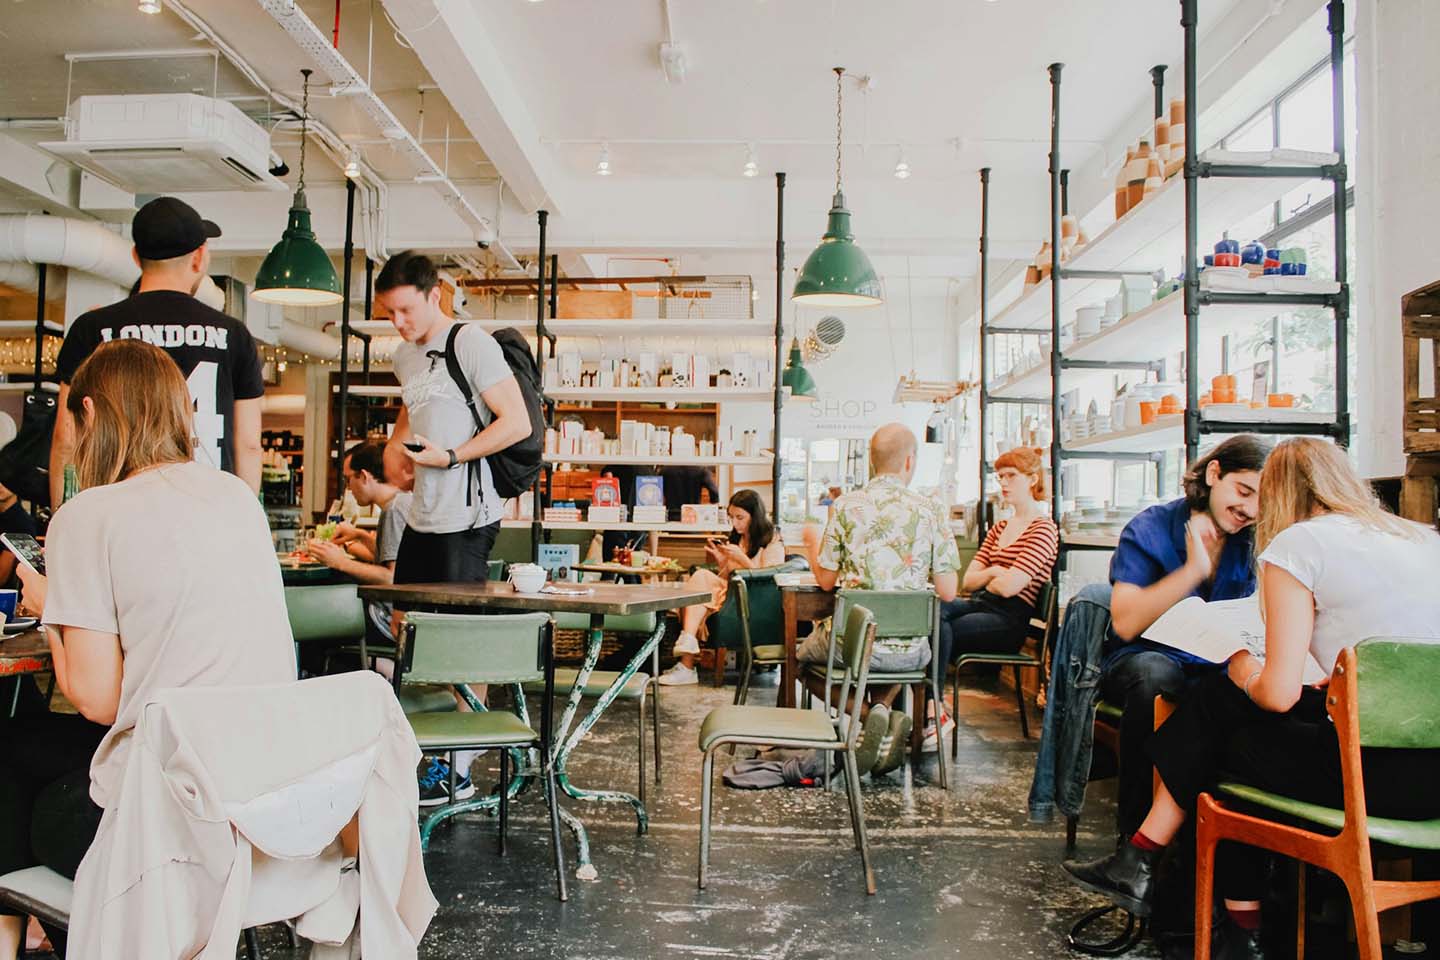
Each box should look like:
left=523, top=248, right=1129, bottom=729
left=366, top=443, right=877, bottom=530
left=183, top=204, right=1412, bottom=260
left=700, top=604, right=876, bottom=894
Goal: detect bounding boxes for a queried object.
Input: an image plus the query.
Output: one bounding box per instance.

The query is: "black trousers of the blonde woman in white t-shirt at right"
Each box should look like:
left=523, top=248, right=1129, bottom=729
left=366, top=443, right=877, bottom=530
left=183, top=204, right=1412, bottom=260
left=1146, top=672, right=1440, bottom=900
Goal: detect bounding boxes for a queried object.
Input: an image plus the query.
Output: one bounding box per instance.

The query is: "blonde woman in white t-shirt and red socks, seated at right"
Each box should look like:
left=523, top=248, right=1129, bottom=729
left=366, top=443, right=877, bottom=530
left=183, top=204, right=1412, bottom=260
left=1066, top=438, right=1440, bottom=957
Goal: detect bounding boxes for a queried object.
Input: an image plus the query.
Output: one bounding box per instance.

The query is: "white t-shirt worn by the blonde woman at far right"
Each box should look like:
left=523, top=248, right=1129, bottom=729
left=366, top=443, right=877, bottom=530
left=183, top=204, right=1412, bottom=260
left=1260, top=514, right=1440, bottom=674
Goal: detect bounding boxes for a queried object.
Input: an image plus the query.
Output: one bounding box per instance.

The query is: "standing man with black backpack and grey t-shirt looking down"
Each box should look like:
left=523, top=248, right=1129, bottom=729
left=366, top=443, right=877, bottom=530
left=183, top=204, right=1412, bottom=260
left=374, top=250, right=539, bottom=583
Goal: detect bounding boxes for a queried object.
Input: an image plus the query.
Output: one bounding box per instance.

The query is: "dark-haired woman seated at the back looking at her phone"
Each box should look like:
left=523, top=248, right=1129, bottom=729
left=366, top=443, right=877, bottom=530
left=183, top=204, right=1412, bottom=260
left=660, top=489, right=785, bottom=687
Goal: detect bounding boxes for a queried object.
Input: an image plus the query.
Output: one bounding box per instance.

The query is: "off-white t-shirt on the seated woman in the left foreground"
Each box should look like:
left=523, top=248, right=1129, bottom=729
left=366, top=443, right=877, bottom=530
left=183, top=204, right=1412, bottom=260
left=45, top=462, right=295, bottom=807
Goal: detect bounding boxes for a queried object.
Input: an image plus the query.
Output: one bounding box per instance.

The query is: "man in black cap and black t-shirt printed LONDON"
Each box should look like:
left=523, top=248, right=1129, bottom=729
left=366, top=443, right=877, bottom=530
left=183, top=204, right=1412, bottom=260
left=50, top=197, right=265, bottom=507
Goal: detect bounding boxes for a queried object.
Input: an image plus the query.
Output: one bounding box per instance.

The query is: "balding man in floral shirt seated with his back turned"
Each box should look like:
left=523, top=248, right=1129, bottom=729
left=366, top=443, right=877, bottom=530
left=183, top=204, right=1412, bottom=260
left=796, top=423, right=960, bottom=774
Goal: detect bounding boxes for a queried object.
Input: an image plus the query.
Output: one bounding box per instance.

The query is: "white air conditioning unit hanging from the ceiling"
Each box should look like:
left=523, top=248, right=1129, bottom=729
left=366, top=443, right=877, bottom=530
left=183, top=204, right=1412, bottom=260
left=40, top=94, right=287, bottom=193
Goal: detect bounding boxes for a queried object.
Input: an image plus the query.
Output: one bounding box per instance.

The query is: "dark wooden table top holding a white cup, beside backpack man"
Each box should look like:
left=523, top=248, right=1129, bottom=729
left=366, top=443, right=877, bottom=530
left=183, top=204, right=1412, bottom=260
left=360, top=580, right=713, bottom=616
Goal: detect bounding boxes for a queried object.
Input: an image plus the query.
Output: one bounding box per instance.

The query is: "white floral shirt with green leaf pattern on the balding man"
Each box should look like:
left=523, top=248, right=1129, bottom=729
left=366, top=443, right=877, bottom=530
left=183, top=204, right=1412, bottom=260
left=819, top=475, right=960, bottom=653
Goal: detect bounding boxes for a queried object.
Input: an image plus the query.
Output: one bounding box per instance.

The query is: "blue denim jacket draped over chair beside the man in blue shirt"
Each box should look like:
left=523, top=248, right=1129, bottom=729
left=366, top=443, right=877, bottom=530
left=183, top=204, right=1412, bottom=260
left=1030, top=583, right=1110, bottom=823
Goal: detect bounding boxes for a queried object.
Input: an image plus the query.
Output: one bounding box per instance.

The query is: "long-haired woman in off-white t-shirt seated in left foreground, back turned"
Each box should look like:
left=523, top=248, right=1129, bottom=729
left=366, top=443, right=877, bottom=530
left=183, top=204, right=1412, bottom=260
left=0, top=340, right=295, bottom=957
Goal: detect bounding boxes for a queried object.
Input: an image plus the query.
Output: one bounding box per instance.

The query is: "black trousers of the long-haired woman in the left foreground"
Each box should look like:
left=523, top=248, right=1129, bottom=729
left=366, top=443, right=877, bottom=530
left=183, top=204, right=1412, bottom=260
left=0, top=714, right=109, bottom=892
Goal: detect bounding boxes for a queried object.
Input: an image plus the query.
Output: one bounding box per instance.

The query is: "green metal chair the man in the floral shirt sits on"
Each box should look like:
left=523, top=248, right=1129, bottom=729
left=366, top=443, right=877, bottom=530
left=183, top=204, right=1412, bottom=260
left=805, top=590, right=950, bottom=790
